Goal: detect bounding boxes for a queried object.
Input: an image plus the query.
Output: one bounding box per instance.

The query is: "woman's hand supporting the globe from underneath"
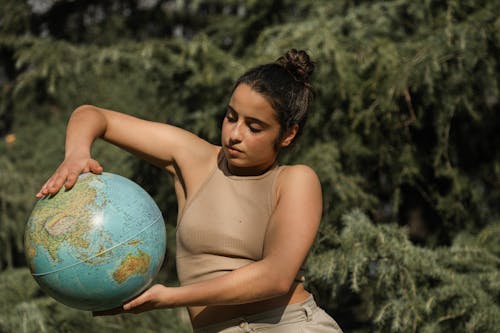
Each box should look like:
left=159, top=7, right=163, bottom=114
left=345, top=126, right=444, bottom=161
left=92, top=284, right=168, bottom=316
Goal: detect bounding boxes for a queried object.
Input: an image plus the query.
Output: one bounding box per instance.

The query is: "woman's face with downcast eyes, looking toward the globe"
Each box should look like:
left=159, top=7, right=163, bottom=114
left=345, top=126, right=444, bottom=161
left=221, top=84, right=293, bottom=176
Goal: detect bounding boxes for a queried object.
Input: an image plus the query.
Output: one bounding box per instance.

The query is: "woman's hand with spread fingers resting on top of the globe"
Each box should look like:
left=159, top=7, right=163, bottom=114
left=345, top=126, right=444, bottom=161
left=36, top=157, right=103, bottom=198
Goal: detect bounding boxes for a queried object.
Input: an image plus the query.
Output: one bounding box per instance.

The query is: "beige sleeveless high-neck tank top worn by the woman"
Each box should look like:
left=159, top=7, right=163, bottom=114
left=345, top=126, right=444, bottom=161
left=176, top=153, right=303, bottom=285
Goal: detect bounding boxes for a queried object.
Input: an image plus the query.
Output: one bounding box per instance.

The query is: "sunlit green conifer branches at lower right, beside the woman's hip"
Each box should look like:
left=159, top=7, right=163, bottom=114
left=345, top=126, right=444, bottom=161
left=308, top=210, right=500, bottom=333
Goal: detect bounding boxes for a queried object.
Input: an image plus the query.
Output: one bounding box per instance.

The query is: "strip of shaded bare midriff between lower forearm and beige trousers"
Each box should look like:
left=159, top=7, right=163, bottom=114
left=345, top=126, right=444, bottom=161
left=188, top=282, right=310, bottom=328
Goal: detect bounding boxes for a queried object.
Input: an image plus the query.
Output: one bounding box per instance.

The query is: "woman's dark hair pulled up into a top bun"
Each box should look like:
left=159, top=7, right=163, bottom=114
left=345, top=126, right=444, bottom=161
left=233, top=49, right=315, bottom=148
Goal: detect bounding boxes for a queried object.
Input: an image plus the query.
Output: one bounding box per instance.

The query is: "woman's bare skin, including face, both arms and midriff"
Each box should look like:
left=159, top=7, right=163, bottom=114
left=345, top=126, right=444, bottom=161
left=37, top=84, right=322, bottom=327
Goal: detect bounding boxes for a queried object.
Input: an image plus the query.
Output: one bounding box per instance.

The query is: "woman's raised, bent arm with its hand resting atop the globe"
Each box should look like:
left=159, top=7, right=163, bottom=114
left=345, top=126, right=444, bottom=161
left=37, top=105, right=214, bottom=197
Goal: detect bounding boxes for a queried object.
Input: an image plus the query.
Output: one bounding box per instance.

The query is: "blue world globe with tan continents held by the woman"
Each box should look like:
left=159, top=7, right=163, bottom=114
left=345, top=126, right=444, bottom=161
left=24, top=172, right=166, bottom=311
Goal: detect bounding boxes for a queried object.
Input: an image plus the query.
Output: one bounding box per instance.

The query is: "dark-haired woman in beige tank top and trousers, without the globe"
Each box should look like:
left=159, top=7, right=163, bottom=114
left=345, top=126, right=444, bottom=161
left=37, top=49, right=341, bottom=332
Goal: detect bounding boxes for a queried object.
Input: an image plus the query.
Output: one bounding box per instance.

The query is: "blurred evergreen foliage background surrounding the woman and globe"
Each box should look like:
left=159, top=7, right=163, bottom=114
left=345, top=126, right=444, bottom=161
left=0, top=0, right=500, bottom=333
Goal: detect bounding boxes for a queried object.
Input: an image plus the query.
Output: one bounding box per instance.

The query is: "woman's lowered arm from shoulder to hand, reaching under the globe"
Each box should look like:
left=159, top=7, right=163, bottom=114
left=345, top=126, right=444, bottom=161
left=109, top=166, right=322, bottom=313
